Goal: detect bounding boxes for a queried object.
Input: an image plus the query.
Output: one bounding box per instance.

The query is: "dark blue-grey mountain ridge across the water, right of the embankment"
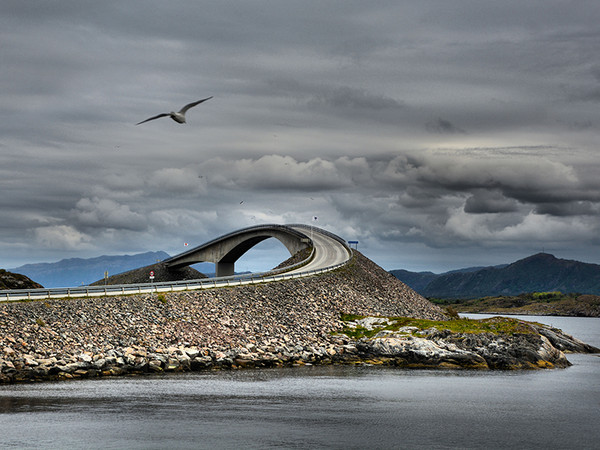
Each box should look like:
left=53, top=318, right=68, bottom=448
left=391, top=253, right=600, bottom=299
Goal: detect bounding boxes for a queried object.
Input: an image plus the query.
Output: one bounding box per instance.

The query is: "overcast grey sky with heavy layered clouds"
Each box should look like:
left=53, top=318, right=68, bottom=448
left=0, top=0, right=600, bottom=273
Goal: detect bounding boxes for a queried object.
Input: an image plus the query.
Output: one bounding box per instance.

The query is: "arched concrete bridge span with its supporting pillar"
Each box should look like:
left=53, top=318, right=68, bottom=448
left=163, top=225, right=312, bottom=277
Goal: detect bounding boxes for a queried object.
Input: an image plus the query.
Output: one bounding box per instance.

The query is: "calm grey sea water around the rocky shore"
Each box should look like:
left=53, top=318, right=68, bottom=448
left=0, top=315, right=600, bottom=449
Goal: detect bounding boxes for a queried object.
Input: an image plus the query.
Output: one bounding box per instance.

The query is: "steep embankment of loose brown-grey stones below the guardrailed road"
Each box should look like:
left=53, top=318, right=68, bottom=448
left=0, top=253, right=596, bottom=383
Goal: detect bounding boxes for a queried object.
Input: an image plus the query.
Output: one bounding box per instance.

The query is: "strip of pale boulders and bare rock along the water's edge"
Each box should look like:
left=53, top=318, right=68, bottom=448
left=0, top=317, right=600, bottom=384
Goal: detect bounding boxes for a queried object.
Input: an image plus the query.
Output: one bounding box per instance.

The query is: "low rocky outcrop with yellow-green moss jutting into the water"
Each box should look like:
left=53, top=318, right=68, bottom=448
left=346, top=317, right=600, bottom=370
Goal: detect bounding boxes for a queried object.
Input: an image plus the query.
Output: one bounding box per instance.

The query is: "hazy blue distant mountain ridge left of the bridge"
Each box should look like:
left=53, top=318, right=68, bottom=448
left=9, top=251, right=169, bottom=288
